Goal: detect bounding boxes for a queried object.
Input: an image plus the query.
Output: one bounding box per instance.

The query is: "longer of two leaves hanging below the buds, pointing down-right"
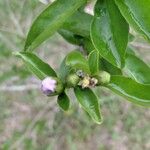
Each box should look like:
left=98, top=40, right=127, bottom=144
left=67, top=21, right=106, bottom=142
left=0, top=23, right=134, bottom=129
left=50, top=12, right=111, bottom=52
left=74, top=87, right=102, bottom=124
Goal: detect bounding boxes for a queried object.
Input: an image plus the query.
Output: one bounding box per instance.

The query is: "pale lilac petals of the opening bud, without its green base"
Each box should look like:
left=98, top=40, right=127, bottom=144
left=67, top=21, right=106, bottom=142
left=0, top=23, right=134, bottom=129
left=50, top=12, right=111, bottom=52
left=41, top=77, right=57, bottom=96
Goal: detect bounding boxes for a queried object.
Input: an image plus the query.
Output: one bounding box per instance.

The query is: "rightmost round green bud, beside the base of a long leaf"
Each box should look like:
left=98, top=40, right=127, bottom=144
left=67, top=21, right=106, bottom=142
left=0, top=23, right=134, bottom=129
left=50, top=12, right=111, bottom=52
left=97, top=71, right=111, bottom=85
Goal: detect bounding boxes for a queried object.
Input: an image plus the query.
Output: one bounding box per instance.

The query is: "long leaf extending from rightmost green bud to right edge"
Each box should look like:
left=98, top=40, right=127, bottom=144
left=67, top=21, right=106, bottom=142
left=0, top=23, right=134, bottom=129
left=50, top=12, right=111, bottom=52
left=107, top=76, right=150, bottom=107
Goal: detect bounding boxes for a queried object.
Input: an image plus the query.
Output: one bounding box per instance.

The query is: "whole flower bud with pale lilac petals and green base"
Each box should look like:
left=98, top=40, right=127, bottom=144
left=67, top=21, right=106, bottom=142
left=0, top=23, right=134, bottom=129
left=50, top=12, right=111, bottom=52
left=41, top=77, right=63, bottom=96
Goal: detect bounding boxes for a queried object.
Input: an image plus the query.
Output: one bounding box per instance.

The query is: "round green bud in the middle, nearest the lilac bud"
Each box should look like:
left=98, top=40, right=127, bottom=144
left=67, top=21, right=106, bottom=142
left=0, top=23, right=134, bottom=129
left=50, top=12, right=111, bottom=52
left=66, top=73, right=80, bottom=87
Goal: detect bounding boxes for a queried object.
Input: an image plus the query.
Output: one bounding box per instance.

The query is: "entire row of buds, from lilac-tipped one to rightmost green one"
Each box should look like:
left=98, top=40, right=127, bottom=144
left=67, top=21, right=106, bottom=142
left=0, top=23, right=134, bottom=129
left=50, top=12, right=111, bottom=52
left=41, top=70, right=110, bottom=96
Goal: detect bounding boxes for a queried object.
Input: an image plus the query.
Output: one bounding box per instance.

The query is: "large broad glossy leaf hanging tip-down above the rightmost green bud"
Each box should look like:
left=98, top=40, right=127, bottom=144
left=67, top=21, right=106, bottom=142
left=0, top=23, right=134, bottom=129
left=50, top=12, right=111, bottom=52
left=91, top=0, right=129, bottom=68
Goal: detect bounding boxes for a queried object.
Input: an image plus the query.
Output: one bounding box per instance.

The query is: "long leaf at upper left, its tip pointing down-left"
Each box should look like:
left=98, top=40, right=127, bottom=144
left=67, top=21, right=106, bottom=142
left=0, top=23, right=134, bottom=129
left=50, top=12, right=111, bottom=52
left=24, top=0, right=86, bottom=50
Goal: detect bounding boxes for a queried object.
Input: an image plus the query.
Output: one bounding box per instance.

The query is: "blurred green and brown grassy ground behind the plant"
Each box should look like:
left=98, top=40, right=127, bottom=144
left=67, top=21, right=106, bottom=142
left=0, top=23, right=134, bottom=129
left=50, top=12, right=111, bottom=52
left=0, top=0, right=150, bottom=150
